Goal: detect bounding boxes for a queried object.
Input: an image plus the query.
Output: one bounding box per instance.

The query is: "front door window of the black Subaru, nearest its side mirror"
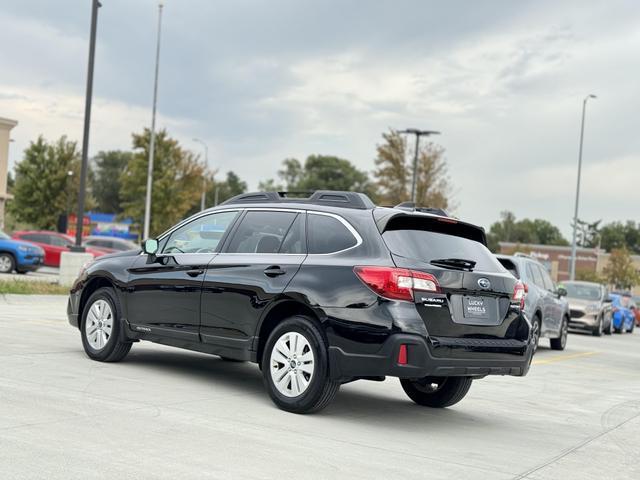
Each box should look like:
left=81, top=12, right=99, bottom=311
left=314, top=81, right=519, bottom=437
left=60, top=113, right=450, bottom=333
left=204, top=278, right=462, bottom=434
left=162, top=211, right=238, bottom=253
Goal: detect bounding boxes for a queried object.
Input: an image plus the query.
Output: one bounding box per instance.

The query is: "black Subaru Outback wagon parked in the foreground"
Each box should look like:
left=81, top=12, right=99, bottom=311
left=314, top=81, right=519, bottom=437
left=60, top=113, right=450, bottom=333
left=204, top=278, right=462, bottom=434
left=68, top=191, right=532, bottom=413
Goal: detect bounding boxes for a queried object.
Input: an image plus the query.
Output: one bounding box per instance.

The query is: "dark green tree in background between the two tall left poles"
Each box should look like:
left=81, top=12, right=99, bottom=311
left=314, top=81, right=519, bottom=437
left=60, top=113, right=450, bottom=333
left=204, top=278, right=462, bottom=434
left=93, top=150, right=133, bottom=214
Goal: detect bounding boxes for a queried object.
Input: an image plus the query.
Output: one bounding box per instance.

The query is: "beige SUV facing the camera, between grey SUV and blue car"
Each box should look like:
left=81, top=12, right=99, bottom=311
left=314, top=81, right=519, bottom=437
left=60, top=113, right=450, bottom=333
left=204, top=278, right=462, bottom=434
left=562, top=281, right=612, bottom=337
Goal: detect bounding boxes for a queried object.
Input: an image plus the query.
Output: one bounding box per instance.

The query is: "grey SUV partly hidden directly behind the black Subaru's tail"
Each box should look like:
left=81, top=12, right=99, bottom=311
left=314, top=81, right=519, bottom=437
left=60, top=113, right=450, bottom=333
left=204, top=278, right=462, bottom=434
left=497, top=253, right=570, bottom=351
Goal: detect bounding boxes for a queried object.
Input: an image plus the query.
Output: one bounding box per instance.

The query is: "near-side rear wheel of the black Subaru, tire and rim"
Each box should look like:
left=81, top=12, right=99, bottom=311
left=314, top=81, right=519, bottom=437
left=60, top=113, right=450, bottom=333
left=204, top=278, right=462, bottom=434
left=261, top=316, right=340, bottom=413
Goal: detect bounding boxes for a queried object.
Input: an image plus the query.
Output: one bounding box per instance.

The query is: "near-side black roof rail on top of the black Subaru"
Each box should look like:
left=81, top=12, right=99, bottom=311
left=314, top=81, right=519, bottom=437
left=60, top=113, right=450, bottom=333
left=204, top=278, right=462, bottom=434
left=221, top=190, right=375, bottom=210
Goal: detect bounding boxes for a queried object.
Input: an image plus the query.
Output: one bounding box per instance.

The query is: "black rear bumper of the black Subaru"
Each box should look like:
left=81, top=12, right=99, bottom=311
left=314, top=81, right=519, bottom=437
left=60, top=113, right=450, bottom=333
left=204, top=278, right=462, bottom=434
left=329, top=333, right=533, bottom=381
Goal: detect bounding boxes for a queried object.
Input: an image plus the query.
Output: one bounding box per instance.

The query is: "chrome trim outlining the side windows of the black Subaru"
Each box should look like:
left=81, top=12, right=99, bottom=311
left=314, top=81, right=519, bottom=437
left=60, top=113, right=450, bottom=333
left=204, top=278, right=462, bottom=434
left=146, top=207, right=362, bottom=257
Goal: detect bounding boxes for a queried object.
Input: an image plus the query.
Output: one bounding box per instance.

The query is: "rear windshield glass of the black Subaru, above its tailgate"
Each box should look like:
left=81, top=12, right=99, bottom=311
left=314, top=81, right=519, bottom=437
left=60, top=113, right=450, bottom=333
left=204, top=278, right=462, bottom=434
left=382, top=229, right=505, bottom=272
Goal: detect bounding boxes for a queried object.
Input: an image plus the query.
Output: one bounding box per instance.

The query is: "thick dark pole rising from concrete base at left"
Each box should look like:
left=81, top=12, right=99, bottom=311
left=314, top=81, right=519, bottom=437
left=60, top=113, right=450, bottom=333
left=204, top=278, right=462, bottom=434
left=73, top=0, right=102, bottom=248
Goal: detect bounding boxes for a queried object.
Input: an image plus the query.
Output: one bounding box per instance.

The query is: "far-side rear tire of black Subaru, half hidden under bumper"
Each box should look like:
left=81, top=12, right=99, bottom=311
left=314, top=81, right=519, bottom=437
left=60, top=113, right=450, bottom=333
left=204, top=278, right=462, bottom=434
left=400, top=377, right=472, bottom=408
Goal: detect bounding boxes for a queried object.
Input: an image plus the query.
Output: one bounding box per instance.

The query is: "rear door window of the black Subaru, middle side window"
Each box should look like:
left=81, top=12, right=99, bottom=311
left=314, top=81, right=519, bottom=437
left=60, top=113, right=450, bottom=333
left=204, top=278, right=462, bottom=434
left=227, top=210, right=298, bottom=253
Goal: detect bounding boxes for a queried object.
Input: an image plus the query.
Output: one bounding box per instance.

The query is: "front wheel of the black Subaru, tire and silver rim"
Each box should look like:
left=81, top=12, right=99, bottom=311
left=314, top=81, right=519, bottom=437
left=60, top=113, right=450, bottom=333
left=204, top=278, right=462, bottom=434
left=80, top=288, right=131, bottom=362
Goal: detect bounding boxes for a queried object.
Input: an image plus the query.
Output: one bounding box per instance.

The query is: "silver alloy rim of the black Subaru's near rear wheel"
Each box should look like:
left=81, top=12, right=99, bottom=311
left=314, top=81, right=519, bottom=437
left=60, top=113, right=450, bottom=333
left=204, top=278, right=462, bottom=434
left=269, top=332, right=315, bottom=398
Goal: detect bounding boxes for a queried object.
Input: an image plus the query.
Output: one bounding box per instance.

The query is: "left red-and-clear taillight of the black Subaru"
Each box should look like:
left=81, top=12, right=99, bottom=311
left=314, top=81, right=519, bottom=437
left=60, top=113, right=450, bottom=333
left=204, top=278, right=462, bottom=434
left=353, top=267, right=440, bottom=302
